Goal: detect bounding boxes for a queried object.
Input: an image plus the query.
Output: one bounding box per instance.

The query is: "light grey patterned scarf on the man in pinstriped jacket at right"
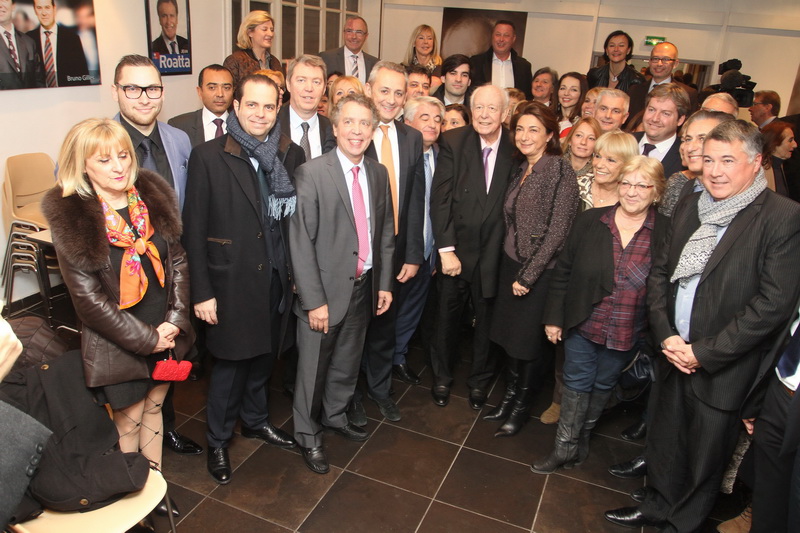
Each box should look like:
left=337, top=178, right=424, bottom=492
left=670, top=169, right=767, bottom=287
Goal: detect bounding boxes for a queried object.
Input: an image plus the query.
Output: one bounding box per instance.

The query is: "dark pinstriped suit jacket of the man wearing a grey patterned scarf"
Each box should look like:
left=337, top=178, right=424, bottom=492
left=647, top=189, right=800, bottom=411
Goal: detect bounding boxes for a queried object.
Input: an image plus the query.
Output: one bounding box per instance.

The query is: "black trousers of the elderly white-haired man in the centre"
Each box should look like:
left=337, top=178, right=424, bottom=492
left=431, top=269, right=494, bottom=389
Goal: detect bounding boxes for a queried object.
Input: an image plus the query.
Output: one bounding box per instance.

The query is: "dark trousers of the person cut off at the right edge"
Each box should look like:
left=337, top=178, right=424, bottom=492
left=750, top=375, right=800, bottom=533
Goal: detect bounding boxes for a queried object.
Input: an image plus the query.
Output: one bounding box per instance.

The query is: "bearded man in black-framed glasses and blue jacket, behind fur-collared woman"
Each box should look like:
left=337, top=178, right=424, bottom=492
left=112, top=55, right=198, bottom=468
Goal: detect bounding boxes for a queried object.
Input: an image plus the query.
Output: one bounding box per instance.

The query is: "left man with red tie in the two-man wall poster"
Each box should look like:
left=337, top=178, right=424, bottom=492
left=0, top=0, right=45, bottom=90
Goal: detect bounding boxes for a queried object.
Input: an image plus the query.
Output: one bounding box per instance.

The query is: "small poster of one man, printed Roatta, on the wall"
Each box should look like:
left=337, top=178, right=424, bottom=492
left=144, top=0, right=192, bottom=76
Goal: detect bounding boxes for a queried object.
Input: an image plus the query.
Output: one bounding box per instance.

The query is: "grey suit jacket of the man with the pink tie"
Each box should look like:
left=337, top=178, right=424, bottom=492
left=289, top=150, right=394, bottom=326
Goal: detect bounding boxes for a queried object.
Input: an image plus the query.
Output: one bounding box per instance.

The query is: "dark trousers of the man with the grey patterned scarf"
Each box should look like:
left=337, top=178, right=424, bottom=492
left=639, top=369, right=742, bottom=533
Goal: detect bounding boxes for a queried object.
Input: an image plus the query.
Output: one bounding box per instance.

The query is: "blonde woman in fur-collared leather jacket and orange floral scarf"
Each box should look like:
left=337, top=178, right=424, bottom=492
left=42, top=119, right=194, bottom=494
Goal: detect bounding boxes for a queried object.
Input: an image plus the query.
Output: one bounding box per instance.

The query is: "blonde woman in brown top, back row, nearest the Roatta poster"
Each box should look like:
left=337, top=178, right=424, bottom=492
left=222, top=10, right=281, bottom=87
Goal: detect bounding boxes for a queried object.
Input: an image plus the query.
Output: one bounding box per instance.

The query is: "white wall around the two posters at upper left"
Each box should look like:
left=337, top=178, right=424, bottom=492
left=0, top=0, right=230, bottom=300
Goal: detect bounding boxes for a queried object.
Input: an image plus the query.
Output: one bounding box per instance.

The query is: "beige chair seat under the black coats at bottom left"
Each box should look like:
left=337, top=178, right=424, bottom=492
left=10, top=470, right=174, bottom=533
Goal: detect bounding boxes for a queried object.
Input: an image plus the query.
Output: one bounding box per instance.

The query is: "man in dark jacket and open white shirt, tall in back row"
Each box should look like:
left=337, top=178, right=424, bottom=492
left=468, top=20, right=533, bottom=100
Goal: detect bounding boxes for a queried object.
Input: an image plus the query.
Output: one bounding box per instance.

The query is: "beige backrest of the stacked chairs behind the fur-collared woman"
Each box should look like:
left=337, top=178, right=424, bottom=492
left=3, top=152, right=56, bottom=229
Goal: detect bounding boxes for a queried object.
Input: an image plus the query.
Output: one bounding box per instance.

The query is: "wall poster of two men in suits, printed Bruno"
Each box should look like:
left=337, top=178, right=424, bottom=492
left=0, top=0, right=100, bottom=90
